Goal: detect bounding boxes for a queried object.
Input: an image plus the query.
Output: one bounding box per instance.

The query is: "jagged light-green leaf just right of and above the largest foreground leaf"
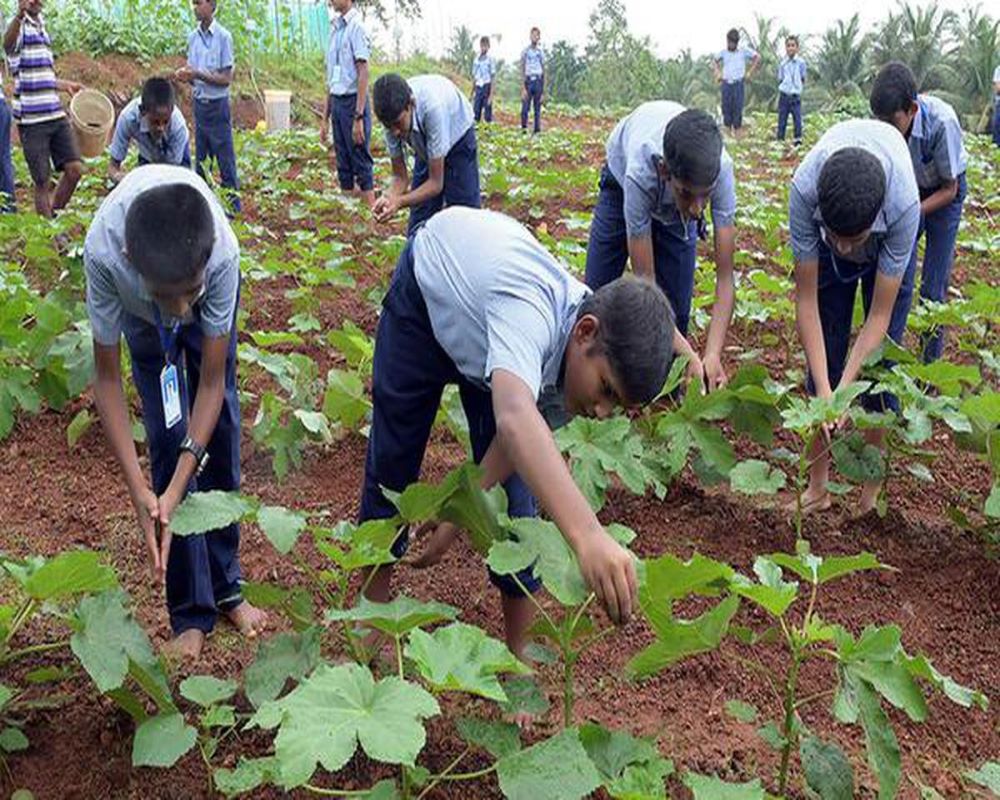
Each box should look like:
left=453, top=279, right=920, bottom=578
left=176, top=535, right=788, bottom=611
left=405, top=622, right=531, bottom=702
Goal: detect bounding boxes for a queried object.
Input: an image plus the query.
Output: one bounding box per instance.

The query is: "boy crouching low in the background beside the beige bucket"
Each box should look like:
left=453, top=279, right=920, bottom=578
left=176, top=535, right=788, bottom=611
left=108, top=78, right=191, bottom=183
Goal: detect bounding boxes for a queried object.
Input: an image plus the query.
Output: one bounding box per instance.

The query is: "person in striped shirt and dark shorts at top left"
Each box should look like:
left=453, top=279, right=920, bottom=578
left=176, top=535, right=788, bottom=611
left=3, top=0, right=83, bottom=217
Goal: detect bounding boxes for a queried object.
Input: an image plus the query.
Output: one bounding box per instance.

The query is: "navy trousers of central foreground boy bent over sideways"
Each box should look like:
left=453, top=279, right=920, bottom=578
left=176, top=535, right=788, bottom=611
left=360, top=239, right=541, bottom=596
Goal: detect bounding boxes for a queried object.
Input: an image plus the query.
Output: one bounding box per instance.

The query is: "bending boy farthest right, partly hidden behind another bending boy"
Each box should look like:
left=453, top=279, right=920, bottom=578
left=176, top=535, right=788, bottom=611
left=869, top=61, right=968, bottom=362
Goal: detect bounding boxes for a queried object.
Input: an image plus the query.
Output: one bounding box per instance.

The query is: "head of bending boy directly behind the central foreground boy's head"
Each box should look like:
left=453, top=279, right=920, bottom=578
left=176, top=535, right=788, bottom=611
left=660, top=108, right=722, bottom=218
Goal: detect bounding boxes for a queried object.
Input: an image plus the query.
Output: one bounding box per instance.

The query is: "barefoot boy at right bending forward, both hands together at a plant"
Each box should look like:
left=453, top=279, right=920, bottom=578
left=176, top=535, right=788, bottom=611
left=788, top=120, right=920, bottom=513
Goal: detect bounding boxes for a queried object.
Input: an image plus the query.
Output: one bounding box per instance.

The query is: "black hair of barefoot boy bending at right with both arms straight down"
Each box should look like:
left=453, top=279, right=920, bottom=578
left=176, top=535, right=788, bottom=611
left=817, top=147, right=885, bottom=236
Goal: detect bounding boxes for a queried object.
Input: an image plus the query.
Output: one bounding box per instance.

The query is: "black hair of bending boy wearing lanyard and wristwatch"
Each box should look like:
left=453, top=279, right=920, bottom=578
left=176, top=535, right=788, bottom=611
left=125, top=183, right=215, bottom=286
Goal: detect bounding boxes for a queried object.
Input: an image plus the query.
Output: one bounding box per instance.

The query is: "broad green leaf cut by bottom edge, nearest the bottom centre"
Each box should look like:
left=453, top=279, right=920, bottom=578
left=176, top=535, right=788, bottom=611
left=497, top=728, right=601, bottom=800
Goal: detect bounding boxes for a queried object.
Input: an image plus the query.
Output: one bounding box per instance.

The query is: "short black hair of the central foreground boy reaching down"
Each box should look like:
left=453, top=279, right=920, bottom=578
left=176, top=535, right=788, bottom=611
left=577, top=275, right=674, bottom=406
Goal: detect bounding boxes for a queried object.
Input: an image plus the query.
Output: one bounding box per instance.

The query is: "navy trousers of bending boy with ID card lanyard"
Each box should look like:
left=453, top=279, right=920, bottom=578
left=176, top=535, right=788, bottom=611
left=124, top=296, right=242, bottom=634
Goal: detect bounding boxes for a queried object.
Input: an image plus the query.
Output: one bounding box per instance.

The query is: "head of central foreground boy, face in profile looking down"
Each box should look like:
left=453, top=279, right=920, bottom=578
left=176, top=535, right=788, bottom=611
left=563, top=276, right=674, bottom=419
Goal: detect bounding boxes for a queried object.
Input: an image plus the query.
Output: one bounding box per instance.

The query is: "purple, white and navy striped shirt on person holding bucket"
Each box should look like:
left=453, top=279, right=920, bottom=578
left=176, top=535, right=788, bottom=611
left=8, top=14, right=66, bottom=125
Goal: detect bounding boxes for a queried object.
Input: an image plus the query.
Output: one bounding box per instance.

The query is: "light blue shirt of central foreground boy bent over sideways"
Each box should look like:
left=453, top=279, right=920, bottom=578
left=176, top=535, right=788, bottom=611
left=413, top=206, right=590, bottom=400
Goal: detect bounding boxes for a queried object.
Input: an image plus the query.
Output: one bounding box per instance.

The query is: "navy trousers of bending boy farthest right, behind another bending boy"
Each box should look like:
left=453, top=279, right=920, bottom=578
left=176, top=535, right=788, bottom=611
left=910, top=177, right=968, bottom=363
